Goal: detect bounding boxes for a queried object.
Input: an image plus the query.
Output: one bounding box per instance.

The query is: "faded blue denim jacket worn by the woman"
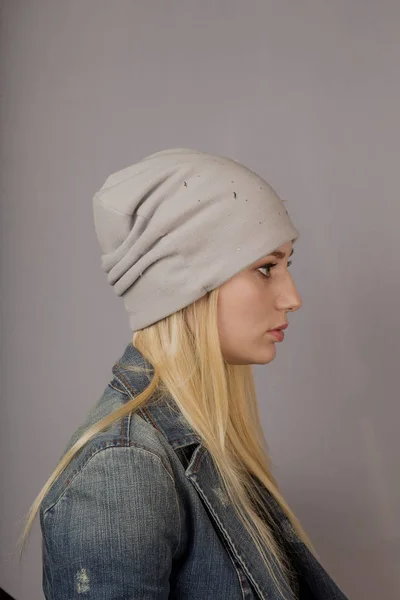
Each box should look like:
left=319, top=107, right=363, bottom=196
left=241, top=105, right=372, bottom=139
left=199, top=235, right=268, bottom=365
left=40, top=343, right=346, bottom=600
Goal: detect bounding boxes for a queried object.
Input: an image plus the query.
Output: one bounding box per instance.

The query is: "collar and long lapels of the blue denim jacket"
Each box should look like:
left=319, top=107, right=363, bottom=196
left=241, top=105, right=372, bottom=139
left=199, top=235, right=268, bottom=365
left=112, top=343, right=346, bottom=600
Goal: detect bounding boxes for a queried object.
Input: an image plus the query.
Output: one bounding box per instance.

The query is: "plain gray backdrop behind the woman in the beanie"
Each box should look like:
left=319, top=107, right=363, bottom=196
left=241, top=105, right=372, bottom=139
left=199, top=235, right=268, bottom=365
left=0, top=0, right=400, bottom=600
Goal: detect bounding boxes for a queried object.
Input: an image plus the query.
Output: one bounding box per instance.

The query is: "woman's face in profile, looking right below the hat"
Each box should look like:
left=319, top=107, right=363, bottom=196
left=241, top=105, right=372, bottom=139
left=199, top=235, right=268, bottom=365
left=218, top=242, right=302, bottom=365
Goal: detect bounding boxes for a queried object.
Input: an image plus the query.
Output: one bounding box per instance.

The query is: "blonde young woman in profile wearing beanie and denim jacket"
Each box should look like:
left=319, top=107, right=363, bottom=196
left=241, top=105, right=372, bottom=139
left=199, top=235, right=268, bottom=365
left=21, top=148, right=345, bottom=600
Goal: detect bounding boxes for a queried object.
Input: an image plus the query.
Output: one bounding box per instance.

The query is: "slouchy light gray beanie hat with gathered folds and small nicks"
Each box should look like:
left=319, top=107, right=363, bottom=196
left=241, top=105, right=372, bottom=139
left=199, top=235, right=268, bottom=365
left=93, top=148, right=299, bottom=331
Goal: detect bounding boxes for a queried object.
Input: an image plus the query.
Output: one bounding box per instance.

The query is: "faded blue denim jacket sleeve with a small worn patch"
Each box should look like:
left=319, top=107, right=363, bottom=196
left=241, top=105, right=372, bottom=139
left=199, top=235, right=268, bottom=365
left=40, top=446, right=180, bottom=600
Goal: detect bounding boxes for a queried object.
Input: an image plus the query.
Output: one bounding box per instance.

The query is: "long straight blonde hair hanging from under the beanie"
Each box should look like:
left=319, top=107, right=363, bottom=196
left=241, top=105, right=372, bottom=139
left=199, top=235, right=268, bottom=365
left=17, top=288, right=316, bottom=589
